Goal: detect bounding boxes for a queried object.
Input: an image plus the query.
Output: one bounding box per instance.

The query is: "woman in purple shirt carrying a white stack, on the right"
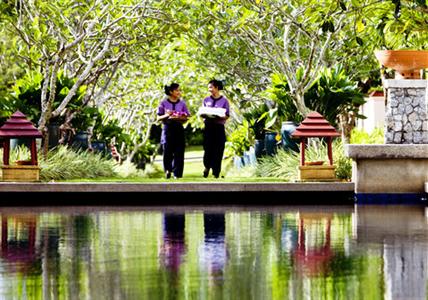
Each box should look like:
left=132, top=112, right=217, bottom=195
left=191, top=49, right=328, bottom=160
left=201, top=79, right=229, bottom=178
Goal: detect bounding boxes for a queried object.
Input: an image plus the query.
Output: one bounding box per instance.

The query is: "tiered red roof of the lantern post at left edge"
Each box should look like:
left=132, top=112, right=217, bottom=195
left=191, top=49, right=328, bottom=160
left=0, top=111, right=42, bottom=138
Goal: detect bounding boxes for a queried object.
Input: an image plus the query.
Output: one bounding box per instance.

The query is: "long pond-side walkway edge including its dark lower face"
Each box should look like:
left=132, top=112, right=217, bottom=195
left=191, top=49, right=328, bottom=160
left=0, top=182, right=355, bottom=207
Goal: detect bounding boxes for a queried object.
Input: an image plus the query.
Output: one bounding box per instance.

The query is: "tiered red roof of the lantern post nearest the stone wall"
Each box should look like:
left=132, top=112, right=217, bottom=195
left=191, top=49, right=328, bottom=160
left=291, top=112, right=340, bottom=137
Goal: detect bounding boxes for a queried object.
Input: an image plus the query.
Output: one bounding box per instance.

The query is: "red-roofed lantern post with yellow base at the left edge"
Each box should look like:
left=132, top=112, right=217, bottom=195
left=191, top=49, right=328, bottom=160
left=0, top=111, right=42, bottom=181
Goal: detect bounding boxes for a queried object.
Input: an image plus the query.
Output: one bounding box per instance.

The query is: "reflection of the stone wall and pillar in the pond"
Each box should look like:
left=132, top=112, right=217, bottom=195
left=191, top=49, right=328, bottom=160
left=357, top=205, right=428, bottom=299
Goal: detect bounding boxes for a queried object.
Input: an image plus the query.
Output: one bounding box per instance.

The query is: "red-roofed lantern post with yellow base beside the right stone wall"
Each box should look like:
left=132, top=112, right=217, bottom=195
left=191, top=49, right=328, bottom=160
left=291, top=112, right=340, bottom=181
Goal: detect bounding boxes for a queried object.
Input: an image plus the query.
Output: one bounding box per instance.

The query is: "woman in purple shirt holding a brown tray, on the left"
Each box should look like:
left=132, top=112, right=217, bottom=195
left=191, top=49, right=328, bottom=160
left=158, top=83, right=190, bottom=179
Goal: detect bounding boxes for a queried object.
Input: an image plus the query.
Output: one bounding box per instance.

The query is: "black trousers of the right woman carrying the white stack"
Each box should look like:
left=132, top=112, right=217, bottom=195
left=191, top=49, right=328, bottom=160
left=204, top=123, right=226, bottom=177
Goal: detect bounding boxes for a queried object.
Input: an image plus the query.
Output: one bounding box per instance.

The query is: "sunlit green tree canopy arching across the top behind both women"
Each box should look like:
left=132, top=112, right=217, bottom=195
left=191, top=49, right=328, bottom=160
left=0, top=0, right=428, bottom=164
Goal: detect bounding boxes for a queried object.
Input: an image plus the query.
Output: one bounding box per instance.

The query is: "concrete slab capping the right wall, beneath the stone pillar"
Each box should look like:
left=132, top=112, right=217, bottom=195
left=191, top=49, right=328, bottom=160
left=345, top=144, right=428, bottom=159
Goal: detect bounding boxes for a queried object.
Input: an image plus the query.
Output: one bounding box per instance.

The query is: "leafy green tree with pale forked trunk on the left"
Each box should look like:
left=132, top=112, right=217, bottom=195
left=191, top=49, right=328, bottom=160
left=2, top=0, right=176, bottom=154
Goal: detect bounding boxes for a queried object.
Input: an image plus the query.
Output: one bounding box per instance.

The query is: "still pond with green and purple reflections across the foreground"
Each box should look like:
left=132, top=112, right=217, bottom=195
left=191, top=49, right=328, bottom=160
left=0, top=205, right=428, bottom=299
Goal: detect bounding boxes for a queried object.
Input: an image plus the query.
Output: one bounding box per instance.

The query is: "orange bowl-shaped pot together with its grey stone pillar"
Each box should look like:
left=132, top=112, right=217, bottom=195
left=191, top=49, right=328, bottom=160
left=375, top=50, right=428, bottom=144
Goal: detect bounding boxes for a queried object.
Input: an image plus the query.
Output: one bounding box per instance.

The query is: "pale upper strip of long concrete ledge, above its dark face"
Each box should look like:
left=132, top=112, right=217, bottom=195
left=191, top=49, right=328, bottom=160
left=0, top=182, right=354, bottom=193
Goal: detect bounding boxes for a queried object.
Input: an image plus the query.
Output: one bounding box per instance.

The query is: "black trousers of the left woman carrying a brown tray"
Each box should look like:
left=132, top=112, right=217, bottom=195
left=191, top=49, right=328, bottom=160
left=163, top=123, right=185, bottom=178
